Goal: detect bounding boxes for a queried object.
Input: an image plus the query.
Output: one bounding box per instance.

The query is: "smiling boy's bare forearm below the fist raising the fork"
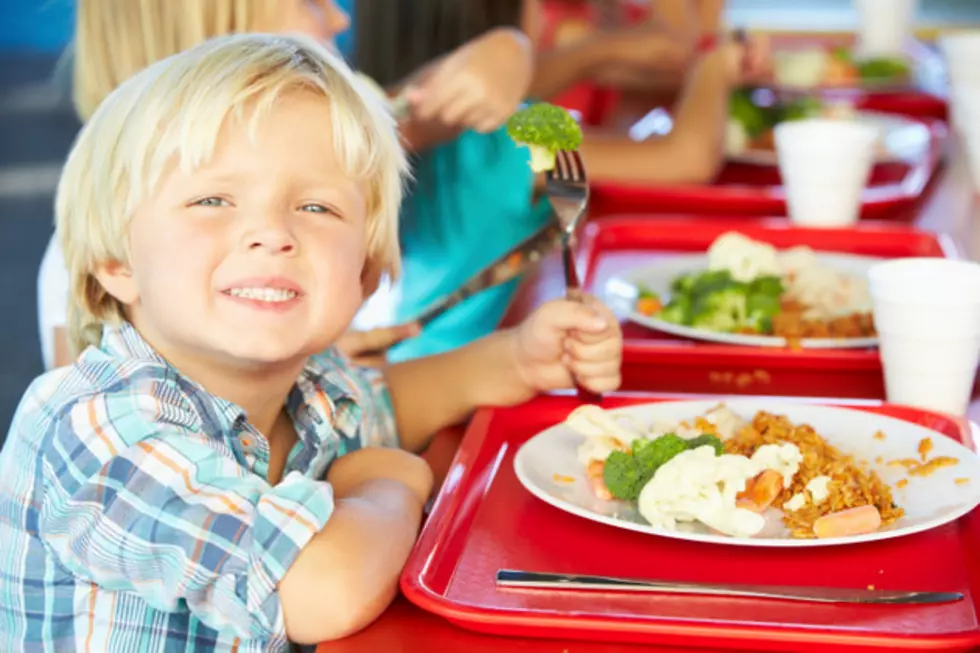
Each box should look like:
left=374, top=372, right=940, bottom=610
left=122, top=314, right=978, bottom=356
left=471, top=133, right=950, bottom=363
left=385, top=331, right=527, bottom=451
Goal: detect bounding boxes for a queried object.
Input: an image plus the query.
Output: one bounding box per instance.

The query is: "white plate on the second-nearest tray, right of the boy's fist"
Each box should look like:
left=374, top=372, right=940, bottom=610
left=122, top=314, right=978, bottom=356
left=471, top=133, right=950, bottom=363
left=605, top=252, right=884, bottom=349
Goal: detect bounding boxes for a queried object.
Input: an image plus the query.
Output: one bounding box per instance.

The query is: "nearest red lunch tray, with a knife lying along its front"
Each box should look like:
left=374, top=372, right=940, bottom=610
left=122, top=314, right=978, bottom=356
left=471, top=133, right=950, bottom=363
left=401, top=395, right=980, bottom=652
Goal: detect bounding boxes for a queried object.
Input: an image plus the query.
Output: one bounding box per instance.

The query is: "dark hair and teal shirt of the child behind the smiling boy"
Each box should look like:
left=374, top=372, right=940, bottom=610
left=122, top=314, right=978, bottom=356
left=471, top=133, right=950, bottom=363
left=354, top=0, right=550, bottom=362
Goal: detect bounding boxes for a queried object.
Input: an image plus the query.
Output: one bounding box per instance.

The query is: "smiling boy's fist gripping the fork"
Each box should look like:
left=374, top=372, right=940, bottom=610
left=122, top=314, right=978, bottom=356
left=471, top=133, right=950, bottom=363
left=515, top=297, right=623, bottom=393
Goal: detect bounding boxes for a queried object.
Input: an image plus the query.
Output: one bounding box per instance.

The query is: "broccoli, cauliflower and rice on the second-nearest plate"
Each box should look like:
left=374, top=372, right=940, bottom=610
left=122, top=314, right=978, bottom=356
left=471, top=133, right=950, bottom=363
left=634, top=232, right=875, bottom=340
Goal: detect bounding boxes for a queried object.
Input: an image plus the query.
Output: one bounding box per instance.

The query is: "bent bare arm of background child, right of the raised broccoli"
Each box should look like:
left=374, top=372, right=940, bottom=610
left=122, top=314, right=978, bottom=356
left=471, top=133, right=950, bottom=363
left=581, top=52, right=729, bottom=184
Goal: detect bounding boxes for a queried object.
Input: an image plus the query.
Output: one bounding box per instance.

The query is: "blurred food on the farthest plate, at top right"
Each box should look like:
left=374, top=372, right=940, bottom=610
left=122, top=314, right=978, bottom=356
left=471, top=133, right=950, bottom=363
left=773, top=47, right=912, bottom=88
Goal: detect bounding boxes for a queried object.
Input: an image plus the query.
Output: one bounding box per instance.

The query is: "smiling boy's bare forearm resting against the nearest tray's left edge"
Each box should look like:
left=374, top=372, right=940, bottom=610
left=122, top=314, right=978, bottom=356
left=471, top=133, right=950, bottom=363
left=279, top=479, right=422, bottom=644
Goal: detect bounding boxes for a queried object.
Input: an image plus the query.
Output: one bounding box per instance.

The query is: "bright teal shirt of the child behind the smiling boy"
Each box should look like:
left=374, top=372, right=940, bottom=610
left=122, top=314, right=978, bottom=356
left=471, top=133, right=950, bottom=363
left=389, top=128, right=551, bottom=361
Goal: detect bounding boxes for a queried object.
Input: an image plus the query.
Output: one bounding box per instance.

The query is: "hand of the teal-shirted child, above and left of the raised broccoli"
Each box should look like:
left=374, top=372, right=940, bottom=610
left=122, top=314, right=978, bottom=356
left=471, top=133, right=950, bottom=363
left=406, top=29, right=534, bottom=132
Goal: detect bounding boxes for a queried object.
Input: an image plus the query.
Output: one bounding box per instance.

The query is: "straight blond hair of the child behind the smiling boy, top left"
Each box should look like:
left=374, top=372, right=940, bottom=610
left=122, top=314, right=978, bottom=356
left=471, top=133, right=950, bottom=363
left=72, top=0, right=282, bottom=121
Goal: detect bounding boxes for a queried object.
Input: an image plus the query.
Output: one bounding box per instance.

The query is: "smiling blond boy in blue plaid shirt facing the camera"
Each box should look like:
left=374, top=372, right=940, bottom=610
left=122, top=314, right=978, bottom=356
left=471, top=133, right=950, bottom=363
left=0, top=35, right=621, bottom=653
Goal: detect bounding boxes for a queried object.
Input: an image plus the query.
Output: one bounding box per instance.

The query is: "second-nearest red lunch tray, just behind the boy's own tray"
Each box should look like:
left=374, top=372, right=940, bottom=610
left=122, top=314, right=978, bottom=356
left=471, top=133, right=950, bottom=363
left=579, top=216, right=956, bottom=399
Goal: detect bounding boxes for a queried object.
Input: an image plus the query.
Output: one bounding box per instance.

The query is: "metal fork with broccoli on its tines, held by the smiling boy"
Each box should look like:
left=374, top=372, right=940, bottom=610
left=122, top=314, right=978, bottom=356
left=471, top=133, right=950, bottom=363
left=545, top=150, right=589, bottom=302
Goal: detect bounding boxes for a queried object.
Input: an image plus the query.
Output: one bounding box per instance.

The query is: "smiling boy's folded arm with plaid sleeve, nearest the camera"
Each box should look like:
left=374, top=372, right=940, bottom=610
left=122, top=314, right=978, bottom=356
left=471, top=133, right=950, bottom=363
left=38, top=394, right=428, bottom=642
